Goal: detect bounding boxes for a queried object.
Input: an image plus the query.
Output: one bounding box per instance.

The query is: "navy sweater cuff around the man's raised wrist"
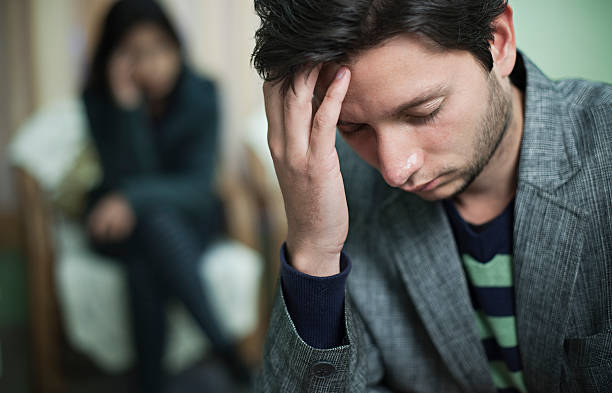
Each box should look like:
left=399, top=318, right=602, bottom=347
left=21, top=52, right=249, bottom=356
left=280, top=245, right=351, bottom=349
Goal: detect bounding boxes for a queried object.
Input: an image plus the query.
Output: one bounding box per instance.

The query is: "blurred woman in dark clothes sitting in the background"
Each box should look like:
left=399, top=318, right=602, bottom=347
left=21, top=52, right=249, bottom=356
left=83, top=0, right=245, bottom=393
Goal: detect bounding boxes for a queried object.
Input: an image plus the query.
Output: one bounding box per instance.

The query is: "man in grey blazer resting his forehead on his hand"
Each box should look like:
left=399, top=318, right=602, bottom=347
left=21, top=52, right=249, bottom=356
left=253, top=0, right=612, bottom=393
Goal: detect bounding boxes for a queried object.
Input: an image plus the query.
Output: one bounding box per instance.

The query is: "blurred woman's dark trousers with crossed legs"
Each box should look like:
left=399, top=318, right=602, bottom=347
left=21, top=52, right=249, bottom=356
left=94, top=209, right=233, bottom=393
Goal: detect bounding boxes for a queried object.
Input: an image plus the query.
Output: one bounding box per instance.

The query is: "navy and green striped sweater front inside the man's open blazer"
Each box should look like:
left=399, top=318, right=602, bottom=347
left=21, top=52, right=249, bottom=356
left=444, top=200, right=527, bottom=393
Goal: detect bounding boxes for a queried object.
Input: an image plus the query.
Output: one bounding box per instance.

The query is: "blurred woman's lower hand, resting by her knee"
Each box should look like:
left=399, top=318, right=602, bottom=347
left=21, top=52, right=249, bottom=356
left=87, top=193, right=136, bottom=242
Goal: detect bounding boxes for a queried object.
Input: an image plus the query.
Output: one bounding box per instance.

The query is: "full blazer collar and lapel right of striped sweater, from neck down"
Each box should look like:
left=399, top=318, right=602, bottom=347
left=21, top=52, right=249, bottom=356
left=514, top=53, right=588, bottom=393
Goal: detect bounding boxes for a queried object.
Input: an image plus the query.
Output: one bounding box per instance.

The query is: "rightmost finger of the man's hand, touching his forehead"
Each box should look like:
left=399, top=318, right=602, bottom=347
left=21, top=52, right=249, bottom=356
left=310, top=67, right=351, bottom=156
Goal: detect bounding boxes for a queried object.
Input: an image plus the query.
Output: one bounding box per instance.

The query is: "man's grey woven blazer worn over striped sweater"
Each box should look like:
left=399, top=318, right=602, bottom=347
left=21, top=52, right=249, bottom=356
left=257, top=53, right=612, bottom=393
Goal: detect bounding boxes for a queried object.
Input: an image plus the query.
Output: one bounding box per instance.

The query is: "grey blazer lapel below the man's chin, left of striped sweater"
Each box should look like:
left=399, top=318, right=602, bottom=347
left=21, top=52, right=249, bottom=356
left=380, top=193, right=495, bottom=393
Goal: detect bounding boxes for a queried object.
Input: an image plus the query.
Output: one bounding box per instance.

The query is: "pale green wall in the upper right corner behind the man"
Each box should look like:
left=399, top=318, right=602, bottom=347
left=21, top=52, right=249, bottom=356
left=509, top=0, right=612, bottom=83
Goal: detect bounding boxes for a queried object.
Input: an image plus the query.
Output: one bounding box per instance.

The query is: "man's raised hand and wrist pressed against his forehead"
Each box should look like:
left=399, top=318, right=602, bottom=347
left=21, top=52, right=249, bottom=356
left=263, top=66, right=350, bottom=276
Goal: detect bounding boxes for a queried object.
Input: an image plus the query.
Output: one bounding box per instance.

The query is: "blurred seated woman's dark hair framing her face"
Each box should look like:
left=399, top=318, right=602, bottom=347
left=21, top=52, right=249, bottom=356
left=85, top=0, right=181, bottom=94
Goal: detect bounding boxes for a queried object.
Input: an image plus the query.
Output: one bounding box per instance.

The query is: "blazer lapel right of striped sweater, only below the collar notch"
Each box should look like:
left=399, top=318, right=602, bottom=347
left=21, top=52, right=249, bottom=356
left=514, top=184, right=584, bottom=393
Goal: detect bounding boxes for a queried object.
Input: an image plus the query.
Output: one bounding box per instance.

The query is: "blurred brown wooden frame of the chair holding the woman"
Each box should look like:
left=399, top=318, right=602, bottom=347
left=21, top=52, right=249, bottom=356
left=15, top=148, right=285, bottom=393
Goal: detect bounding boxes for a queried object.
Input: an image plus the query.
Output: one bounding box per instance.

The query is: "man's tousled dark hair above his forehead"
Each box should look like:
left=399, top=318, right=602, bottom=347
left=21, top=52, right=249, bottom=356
left=251, top=0, right=507, bottom=88
